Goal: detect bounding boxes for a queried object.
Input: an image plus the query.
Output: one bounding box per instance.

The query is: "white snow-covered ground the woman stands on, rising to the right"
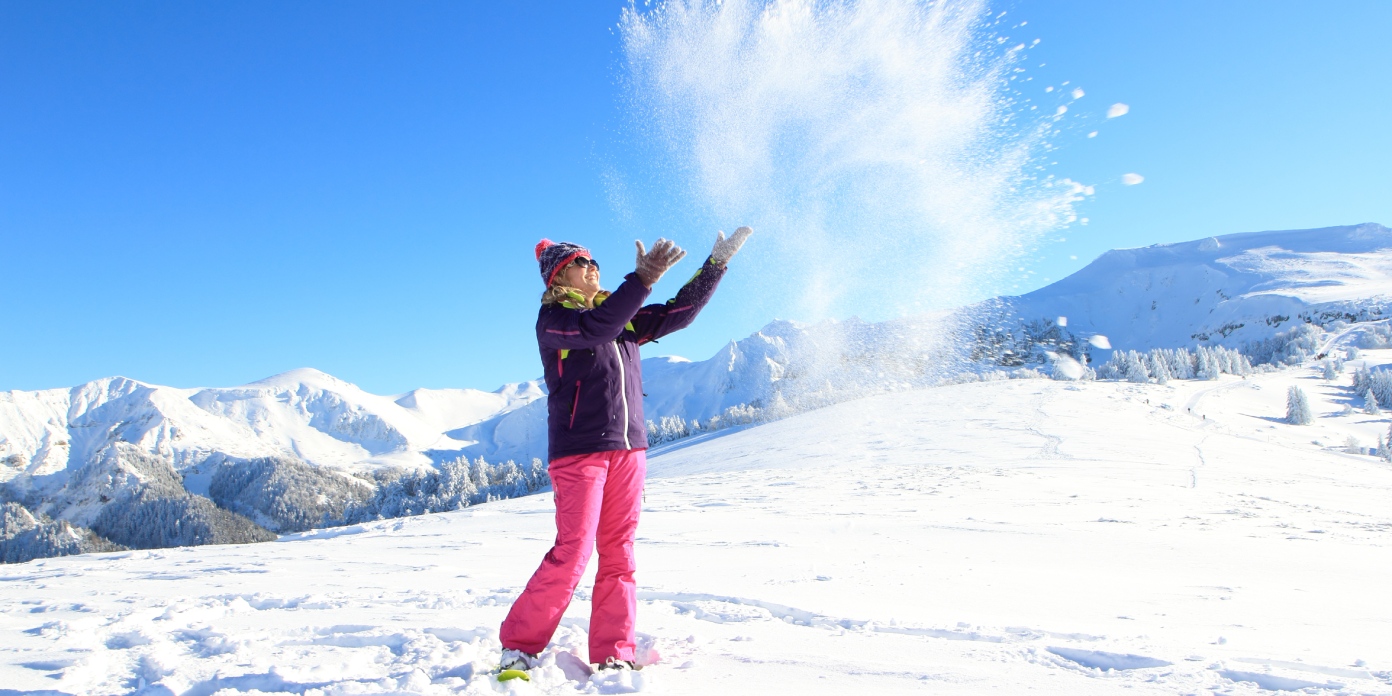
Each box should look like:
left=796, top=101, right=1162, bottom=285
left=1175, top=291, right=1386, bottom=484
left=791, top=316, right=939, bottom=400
left=0, top=351, right=1392, bottom=695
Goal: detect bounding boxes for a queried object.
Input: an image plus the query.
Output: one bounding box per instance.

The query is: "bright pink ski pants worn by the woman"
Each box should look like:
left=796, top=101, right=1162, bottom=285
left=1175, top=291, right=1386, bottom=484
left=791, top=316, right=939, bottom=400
left=500, top=450, right=647, bottom=664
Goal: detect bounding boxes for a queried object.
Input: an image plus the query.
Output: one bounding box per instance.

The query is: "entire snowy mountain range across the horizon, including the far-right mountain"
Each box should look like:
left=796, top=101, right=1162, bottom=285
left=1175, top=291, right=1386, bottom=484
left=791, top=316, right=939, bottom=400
left=0, top=223, right=1392, bottom=559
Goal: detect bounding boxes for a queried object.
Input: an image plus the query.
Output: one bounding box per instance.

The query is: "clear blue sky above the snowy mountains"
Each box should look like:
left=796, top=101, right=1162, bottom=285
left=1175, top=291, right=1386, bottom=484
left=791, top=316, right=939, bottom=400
left=0, top=0, right=1392, bottom=394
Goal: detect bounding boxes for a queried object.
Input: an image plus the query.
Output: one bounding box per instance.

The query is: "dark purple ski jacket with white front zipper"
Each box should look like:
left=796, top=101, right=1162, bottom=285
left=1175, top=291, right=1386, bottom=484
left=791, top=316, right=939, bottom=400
left=536, top=259, right=725, bottom=461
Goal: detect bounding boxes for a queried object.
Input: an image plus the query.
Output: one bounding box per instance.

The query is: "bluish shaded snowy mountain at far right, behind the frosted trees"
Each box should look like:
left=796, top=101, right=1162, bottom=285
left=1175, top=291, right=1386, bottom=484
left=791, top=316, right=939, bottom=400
left=1006, top=223, right=1392, bottom=358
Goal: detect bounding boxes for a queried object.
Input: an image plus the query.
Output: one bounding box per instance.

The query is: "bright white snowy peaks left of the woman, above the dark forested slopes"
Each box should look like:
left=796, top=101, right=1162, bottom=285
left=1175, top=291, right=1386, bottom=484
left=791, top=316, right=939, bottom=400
left=0, top=367, right=546, bottom=490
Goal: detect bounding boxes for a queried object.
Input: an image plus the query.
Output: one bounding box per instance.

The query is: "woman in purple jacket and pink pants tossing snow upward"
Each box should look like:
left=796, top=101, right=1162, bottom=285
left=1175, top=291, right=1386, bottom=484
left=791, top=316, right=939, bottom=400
left=500, top=227, right=753, bottom=671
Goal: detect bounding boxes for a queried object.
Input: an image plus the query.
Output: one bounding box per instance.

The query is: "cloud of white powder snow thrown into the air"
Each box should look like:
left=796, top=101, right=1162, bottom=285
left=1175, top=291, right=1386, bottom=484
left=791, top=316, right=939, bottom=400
left=619, top=0, right=1089, bottom=400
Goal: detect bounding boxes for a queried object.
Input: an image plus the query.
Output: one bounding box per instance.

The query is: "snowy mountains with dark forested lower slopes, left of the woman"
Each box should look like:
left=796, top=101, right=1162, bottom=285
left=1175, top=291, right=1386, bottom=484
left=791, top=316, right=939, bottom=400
left=0, top=369, right=543, bottom=548
